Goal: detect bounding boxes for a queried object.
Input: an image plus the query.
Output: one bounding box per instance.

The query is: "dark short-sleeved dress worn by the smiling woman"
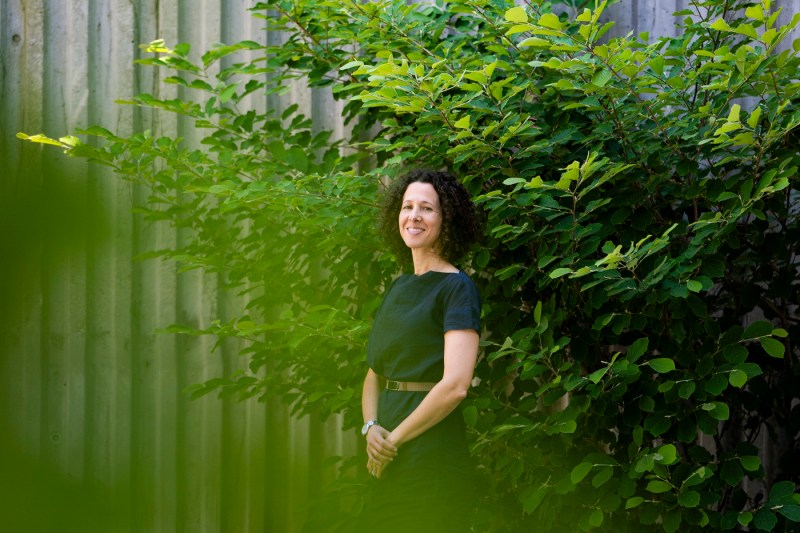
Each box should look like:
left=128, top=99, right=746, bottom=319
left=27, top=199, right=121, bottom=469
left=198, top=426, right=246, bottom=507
left=366, top=271, right=481, bottom=533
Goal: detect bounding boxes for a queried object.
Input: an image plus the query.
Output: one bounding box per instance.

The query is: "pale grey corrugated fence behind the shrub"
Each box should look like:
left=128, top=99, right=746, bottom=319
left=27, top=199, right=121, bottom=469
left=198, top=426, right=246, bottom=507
left=0, top=0, right=800, bottom=532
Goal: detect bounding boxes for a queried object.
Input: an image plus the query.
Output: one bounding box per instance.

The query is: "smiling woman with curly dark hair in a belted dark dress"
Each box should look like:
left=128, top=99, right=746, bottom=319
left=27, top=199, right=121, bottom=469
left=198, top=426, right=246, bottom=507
left=362, top=170, right=480, bottom=533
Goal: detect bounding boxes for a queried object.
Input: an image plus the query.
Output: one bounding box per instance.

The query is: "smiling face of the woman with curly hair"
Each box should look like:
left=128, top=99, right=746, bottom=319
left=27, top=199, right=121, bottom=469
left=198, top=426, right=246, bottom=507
left=398, top=182, right=442, bottom=251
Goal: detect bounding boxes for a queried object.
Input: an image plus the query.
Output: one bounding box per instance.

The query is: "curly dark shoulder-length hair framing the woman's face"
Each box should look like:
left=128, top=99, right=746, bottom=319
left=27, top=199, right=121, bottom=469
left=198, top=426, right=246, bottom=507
left=380, top=169, right=481, bottom=264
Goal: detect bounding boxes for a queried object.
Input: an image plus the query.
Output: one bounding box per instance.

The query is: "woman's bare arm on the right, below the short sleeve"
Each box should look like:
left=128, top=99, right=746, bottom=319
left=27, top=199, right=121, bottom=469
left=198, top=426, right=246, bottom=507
left=387, top=329, right=479, bottom=447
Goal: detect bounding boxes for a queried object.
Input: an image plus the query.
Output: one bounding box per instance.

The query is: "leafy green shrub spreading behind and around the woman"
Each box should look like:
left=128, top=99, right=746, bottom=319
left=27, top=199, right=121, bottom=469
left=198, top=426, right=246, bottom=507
left=18, top=0, right=800, bottom=532
